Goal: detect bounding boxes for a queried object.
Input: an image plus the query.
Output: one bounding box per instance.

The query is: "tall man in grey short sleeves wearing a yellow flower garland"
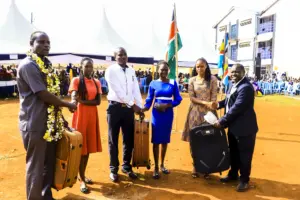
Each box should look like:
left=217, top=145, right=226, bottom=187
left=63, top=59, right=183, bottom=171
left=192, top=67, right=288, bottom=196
left=17, top=31, right=76, bottom=200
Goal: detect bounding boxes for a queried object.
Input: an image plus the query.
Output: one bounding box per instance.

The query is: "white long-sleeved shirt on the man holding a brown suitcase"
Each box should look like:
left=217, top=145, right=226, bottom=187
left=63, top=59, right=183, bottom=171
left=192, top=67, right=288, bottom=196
left=105, top=64, right=143, bottom=108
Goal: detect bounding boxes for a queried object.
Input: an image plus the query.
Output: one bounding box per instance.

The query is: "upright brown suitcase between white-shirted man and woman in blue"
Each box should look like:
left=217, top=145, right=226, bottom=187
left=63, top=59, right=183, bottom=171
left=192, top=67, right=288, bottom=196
left=132, top=119, right=151, bottom=169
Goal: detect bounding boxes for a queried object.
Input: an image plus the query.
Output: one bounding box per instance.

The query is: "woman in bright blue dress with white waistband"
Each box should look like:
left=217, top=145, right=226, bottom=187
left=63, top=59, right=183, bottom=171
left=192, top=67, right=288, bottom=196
left=144, top=61, right=182, bottom=179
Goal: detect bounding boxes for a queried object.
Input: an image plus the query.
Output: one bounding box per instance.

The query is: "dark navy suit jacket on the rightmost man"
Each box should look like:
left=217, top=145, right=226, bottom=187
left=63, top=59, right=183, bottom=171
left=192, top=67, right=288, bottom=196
left=219, top=78, right=258, bottom=136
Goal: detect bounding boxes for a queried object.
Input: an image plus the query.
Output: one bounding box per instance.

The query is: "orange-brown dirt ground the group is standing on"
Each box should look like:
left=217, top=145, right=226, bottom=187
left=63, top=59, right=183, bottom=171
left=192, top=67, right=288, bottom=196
left=0, top=95, right=300, bottom=200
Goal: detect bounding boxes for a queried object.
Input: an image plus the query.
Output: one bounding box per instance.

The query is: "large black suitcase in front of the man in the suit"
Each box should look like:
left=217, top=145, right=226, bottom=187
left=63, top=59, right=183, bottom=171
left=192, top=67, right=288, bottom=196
left=190, top=123, right=230, bottom=174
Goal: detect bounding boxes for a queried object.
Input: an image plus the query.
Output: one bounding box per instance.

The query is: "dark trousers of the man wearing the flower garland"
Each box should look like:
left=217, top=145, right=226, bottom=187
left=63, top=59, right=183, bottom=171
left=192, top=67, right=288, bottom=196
left=22, top=131, right=56, bottom=200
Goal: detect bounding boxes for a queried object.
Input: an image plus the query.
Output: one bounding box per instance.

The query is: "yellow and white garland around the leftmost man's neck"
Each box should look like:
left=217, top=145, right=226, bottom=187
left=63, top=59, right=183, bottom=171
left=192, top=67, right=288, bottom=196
left=27, top=52, right=64, bottom=142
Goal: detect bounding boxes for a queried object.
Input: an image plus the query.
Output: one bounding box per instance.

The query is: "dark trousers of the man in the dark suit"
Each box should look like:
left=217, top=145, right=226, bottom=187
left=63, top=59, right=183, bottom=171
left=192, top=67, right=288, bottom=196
left=228, top=130, right=256, bottom=183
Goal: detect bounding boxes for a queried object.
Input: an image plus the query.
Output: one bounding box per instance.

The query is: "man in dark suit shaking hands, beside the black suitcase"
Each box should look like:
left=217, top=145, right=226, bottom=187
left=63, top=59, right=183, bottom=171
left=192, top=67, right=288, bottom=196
left=214, top=64, right=258, bottom=192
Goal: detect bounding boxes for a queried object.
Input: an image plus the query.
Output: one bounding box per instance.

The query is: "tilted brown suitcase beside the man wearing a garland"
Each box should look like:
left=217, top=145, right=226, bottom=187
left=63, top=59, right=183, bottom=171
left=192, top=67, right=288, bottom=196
left=53, top=130, right=82, bottom=190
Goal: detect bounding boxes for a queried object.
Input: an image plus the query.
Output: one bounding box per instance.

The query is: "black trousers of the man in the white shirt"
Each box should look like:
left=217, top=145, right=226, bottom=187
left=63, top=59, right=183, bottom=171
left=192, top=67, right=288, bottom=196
left=107, top=103, right=134, bottom=174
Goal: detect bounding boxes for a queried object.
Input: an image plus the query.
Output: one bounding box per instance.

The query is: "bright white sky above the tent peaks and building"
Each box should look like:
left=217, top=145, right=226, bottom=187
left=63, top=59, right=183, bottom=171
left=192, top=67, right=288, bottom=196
left=0, top=0, right=274, bottom=59
